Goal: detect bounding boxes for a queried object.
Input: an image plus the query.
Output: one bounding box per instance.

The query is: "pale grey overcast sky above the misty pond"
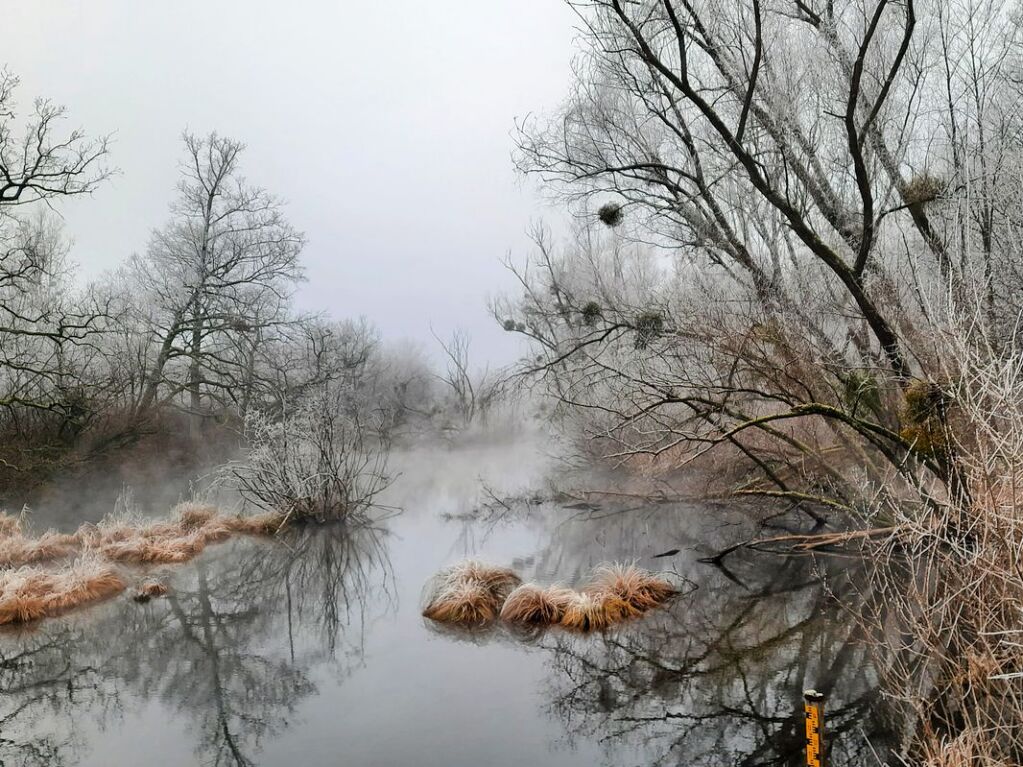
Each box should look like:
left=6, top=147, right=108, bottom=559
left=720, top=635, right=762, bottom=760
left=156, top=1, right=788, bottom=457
left=0, top=0, right=574, bottom=361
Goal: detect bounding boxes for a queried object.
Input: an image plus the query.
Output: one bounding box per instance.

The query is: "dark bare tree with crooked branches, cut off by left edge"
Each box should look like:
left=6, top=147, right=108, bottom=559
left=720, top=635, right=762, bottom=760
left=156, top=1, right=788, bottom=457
left=0, top=71, right=110, bottom=480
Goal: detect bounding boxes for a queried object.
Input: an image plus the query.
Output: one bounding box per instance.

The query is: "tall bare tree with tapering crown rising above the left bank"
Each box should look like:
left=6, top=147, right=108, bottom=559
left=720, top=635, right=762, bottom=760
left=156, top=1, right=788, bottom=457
left=134, top=133, right=304, bottom=422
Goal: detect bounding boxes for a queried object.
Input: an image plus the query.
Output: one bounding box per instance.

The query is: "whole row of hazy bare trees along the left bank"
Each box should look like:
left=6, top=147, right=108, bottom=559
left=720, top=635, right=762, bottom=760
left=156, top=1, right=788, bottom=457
left=0, top=73, right=491, bottom=494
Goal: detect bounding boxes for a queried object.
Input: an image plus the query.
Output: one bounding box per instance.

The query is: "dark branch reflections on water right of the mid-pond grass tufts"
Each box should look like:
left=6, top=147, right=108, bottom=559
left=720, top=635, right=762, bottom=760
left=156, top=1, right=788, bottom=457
left=515, top=512, right=894, bottom=767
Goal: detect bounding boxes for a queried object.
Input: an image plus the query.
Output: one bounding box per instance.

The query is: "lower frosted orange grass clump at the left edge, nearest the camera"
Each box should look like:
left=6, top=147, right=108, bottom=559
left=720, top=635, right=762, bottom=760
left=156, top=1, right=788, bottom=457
left=0, top=556, right=126, bottom=624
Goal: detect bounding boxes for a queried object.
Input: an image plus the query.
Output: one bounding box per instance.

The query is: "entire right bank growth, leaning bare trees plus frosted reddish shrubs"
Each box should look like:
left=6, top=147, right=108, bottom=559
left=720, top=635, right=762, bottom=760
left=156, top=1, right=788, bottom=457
left=503, top=6, right=1023, bottom=765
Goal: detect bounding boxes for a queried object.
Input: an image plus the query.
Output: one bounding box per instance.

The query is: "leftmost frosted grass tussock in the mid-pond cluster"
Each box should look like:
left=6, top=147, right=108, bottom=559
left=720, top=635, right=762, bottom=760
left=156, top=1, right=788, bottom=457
left=422, top=559, right=520, bottom=625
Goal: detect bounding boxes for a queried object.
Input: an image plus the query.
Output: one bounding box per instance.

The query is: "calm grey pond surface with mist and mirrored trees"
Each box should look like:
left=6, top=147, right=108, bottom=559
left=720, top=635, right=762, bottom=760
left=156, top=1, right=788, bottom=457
left=0, top=447, right=896, bottom=767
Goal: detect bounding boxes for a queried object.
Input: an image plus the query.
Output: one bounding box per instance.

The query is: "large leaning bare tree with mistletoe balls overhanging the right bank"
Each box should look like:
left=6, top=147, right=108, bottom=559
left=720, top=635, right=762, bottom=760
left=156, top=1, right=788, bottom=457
left=498, top=0, right=1020, bottom=517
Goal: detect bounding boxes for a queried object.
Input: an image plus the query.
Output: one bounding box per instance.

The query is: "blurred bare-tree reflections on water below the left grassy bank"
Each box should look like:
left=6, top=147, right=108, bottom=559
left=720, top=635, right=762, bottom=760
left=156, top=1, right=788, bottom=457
left=0, top=526, right=393, bottom=767
